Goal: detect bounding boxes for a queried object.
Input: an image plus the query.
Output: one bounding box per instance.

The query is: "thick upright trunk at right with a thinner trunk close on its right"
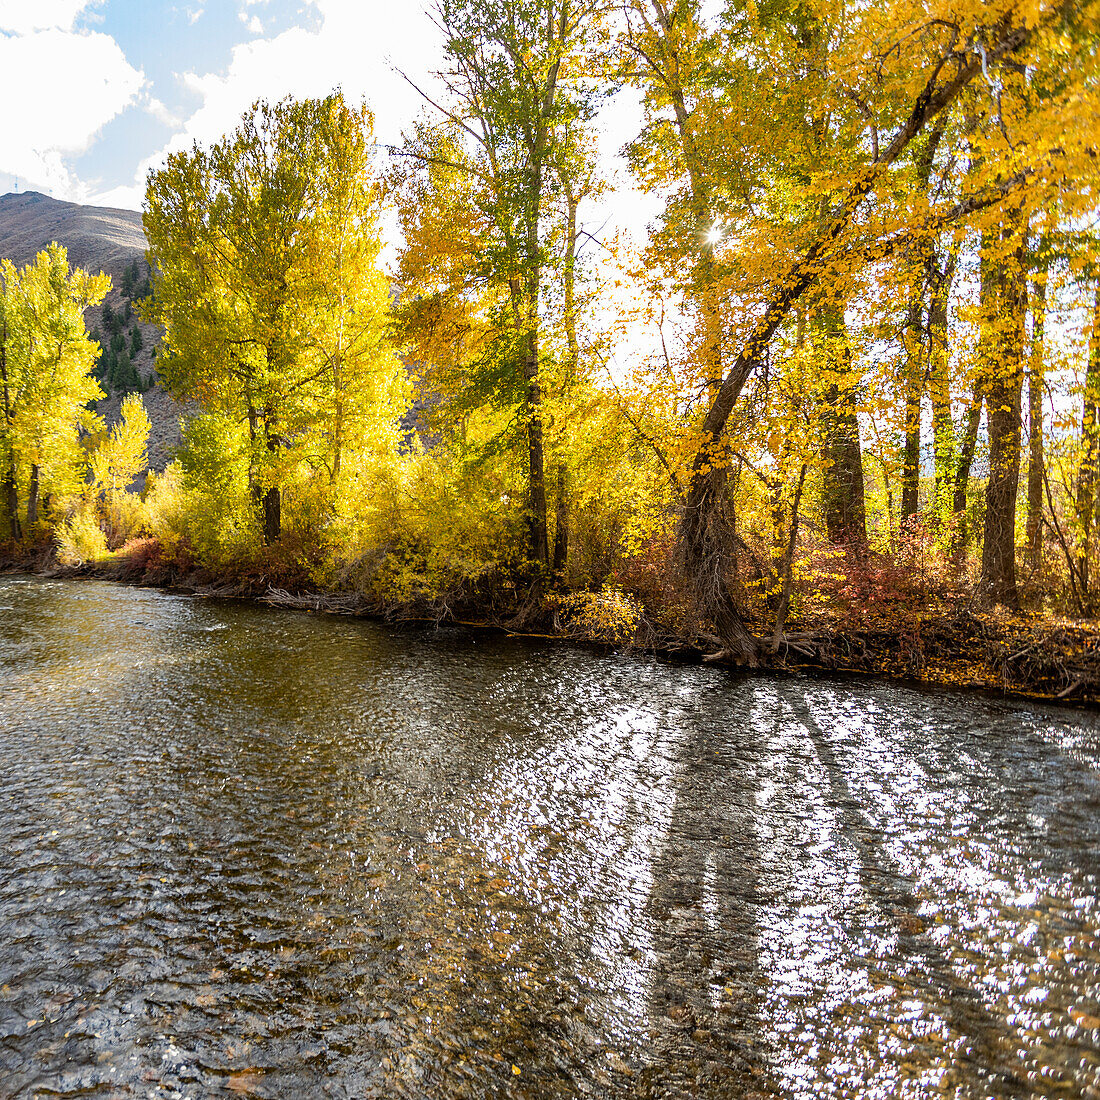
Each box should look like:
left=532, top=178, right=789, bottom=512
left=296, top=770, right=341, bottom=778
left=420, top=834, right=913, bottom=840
left=980, top=216, right=1027, bottom=608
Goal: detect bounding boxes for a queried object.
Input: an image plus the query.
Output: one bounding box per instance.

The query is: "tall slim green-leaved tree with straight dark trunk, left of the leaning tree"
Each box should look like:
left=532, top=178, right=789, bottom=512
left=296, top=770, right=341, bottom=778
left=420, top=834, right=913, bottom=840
left=404, top=0, right=601, bottom=587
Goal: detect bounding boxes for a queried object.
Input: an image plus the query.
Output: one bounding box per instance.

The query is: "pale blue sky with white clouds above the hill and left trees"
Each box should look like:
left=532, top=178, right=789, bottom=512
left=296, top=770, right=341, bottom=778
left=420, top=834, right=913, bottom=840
left=0, top=0, right=459, bottom=210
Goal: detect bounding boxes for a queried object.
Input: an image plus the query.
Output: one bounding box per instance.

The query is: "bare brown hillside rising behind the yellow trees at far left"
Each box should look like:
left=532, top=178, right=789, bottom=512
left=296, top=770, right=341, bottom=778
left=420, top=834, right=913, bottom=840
left=0, top=191, right=180, bottom=471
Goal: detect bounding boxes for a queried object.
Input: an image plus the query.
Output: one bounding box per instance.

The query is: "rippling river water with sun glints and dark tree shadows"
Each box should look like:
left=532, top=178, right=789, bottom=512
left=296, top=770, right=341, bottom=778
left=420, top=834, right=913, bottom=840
left=0, top=576, right=1100, bottom=1100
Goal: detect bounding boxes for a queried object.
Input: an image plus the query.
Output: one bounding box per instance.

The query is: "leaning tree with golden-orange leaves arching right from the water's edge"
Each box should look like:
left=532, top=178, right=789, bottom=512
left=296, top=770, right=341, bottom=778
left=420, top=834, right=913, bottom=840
left=629, top=0, right=1097, bottom=663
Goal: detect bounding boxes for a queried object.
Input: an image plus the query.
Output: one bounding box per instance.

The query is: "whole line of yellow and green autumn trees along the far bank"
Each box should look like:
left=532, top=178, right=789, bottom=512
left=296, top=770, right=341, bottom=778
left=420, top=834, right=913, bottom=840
left=0, top=0, right=1100, bottom=682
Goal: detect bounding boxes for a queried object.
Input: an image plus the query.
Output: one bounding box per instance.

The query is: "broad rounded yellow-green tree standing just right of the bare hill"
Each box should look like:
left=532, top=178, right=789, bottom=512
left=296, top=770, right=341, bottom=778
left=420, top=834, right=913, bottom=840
left=143, top=92, right=395, bottom=543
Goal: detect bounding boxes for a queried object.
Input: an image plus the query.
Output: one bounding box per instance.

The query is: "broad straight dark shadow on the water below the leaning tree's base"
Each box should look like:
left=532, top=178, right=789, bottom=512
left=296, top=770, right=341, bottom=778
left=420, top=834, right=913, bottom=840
left=639, top=685, right=774, bottom=1100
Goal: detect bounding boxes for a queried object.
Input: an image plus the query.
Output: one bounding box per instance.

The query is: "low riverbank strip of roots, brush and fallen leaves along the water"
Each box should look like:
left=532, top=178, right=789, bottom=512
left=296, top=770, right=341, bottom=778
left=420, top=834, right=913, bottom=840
left=0, top=540, right=1100, bottom=707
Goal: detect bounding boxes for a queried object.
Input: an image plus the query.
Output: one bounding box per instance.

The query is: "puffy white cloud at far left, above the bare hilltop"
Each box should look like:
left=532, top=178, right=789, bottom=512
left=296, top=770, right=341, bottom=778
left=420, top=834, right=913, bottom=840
left=0, top=25, right=144, bottom=200
